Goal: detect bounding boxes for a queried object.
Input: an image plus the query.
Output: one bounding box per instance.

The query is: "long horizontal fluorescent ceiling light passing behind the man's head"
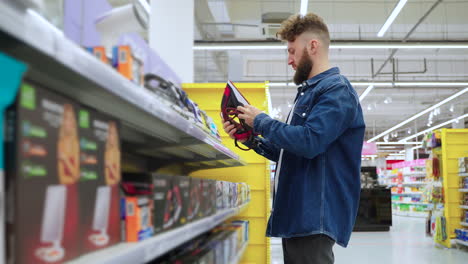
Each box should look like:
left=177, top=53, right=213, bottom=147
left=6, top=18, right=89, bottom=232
left=193, top=43, right=468, bottom=50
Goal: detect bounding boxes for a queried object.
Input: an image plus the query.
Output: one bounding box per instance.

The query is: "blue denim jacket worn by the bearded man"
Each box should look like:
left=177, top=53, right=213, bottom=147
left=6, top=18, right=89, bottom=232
left=247, top=68, right=365, bottom=247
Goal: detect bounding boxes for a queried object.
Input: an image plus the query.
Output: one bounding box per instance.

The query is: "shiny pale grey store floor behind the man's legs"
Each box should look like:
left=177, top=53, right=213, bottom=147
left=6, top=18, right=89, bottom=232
left=271, top=216, right=468, bottom=264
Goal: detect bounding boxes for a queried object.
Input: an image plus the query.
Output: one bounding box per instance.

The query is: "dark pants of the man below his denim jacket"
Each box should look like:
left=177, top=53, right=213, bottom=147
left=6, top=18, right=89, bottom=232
left=283, top=235, right=335, bottom=264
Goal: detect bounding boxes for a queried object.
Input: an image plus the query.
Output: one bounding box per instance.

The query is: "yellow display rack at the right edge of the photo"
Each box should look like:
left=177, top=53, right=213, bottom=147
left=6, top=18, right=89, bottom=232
left=432, top=128, right=468, bottom=248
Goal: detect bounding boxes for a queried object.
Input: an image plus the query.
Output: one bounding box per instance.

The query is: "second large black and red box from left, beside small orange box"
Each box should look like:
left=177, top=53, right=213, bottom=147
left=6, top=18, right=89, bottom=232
left=78, top=107, right=121, bottom=253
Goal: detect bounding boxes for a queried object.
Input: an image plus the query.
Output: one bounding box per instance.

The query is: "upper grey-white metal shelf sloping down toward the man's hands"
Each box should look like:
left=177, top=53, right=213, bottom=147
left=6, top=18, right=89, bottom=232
left=0, top=1, right=245, bottom=169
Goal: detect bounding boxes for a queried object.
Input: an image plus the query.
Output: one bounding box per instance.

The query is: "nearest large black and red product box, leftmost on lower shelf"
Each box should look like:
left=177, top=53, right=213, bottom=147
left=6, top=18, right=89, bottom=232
left=5, top=81, right=81, bottom=264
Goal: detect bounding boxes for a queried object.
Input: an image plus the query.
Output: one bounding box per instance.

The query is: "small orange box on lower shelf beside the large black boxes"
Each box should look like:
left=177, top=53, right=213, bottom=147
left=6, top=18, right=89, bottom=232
left=122, top=195, right=154, bottom=242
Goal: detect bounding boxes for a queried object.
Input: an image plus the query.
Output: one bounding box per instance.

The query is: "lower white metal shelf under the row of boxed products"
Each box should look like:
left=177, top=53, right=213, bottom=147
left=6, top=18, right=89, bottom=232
left=67, top=204, right=248, bottom=264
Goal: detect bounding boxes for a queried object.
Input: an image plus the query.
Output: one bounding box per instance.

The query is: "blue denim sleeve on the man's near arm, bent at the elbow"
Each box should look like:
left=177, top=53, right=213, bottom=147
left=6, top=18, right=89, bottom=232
left=254, top=83, right=359, bottom=159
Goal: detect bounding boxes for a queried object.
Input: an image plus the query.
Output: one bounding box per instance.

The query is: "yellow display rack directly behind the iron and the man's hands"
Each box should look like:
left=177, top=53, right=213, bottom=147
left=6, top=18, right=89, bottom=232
left=183, top=83, right=271, bottom=264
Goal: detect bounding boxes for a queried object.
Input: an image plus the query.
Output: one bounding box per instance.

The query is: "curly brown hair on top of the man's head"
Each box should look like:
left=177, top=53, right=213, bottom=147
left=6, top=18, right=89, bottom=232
left=276, top=13, right=330, bottom=46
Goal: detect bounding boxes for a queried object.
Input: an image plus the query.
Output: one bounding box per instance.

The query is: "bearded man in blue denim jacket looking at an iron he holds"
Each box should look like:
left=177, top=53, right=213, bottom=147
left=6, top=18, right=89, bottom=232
left=224, top=14, right=365, bottom=264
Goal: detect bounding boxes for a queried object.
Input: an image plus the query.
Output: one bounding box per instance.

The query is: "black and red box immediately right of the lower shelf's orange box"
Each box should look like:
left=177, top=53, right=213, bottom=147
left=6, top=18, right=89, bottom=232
left=153, top=174, right=174, bottom=234
